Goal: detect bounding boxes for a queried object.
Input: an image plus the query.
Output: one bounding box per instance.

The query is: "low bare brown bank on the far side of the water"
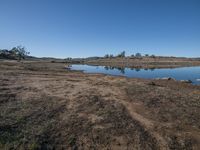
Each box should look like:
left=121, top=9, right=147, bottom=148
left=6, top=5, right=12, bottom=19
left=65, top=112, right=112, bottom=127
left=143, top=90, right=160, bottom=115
left=84, top=56, right=200, bottom=68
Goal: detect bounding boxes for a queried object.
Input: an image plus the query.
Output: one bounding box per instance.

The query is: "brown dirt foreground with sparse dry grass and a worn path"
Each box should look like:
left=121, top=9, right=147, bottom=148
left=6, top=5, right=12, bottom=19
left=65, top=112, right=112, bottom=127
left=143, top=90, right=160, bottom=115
left=0, top=61, right=200, bottom=150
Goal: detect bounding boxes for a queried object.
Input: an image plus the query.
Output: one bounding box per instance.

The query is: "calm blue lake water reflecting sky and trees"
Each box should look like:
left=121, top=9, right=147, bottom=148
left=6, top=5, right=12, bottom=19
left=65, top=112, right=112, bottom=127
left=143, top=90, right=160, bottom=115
left=71, top=65, right=200, bottom=84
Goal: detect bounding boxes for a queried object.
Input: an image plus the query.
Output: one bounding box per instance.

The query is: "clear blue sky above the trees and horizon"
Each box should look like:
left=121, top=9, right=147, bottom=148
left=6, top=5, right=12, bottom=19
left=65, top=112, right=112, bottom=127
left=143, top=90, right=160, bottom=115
left=0, top=0, right=200, bottom=58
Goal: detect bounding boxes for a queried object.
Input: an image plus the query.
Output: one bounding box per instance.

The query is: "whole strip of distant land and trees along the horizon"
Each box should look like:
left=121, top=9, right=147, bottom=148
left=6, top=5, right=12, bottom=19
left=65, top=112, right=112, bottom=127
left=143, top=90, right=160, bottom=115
left=0, top=46, right=200, bottom=69
